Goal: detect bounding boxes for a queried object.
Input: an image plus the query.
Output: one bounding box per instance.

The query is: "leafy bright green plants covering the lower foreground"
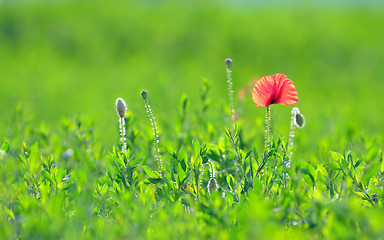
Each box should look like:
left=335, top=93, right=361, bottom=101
left=0, top=97, right=384, bottom=239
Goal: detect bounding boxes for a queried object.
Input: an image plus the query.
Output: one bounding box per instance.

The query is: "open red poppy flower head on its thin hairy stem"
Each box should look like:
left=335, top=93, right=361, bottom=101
left=252, top=73, right=299, bottom=107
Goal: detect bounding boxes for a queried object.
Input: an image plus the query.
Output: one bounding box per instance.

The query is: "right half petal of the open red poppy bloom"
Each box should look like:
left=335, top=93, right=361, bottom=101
left=274, top=75, right=299, bottom=105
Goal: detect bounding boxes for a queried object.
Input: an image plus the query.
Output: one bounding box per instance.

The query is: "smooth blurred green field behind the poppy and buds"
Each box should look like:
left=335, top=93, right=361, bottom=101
left=0, top=0, right=384, bottom=144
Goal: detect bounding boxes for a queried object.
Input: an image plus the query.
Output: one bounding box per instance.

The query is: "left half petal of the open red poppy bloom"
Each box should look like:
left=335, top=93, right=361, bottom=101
left=252, top=76, right=276, bottom=107
